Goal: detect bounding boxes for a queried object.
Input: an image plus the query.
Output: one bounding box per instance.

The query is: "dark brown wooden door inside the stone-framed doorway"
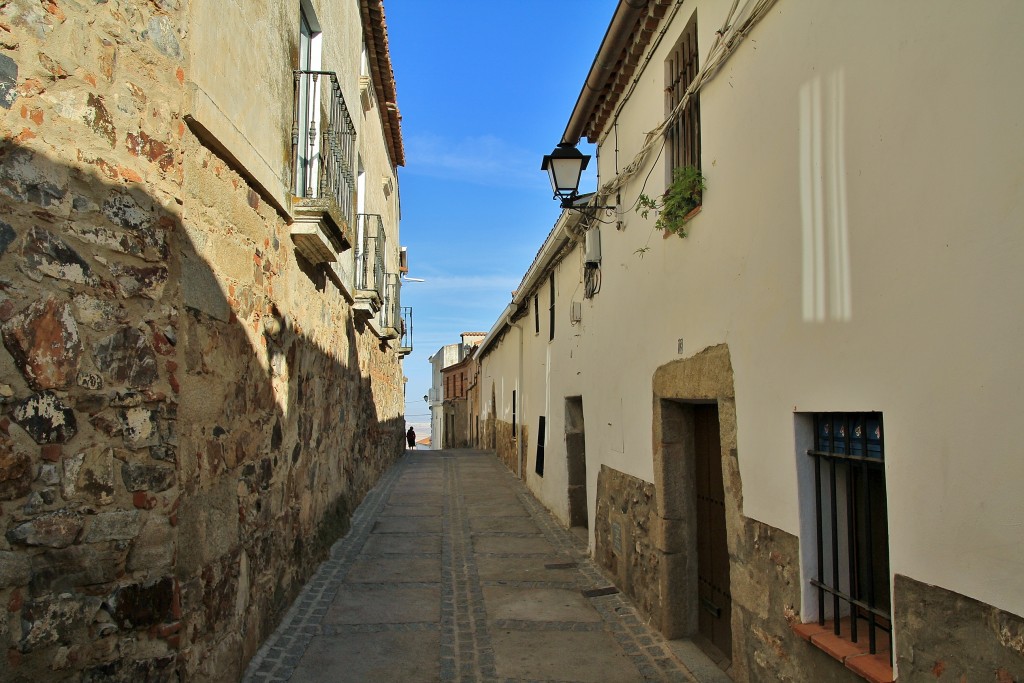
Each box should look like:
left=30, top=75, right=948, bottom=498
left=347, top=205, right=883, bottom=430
left=694, top=405, right=732, bottom=659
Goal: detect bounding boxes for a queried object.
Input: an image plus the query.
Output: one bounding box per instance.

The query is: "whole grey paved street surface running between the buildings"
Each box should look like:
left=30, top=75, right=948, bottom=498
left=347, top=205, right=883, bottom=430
left=244, top=451, right=727, bottom=683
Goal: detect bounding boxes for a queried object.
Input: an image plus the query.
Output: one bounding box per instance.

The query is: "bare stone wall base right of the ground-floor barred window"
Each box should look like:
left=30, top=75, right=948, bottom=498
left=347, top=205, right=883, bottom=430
left=893, top=574, right=1024, bottom=683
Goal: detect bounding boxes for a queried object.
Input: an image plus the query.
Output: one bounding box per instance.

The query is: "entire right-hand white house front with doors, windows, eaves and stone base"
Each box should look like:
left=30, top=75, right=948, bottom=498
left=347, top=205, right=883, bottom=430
left=477, top=0, right=1024, bottom=681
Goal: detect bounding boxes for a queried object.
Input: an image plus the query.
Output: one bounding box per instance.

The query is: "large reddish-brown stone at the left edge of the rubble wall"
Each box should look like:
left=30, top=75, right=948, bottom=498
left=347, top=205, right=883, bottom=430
left=2, top=297, right=82, bottom=391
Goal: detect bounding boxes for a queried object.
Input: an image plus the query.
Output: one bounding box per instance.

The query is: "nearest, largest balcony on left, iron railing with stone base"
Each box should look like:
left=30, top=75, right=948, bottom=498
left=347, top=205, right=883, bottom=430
left=292, top=71, right=355, bottom=263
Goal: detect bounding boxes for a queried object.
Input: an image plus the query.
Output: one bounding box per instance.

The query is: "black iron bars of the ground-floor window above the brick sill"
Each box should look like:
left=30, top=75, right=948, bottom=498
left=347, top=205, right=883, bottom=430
left=807, top=413, right=892, bottom=663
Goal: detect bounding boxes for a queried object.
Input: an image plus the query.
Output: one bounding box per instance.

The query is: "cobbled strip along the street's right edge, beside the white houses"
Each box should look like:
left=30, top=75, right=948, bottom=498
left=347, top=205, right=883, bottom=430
left=516, top=491, right=699, bottom=683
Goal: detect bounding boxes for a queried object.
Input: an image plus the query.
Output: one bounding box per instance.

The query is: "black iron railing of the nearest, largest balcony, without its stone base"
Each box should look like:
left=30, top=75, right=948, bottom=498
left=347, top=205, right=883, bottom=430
left=292, top=71, right=355, bottom=224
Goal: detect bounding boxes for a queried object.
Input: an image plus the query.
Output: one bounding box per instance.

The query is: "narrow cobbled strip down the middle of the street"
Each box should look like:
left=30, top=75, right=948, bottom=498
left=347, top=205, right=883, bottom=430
left=440, top=459, right=498, bottom=683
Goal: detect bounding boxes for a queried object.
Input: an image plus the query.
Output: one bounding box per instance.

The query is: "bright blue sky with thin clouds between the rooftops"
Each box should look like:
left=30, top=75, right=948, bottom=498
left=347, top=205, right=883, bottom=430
left=384, top=0, right=617, bottom=435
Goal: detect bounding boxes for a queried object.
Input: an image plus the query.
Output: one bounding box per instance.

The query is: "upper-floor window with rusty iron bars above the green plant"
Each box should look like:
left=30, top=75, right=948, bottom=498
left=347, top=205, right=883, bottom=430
left=665, top=12, right=700, bottom=182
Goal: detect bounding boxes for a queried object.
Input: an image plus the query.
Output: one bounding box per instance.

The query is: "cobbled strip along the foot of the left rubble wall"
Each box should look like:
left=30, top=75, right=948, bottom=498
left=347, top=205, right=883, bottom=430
left=242, top=459, right=407, bottom=683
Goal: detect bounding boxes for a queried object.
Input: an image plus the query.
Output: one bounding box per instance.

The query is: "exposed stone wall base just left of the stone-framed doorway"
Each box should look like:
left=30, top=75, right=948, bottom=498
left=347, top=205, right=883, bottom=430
left=594, top=465, right=662, bottom=616
